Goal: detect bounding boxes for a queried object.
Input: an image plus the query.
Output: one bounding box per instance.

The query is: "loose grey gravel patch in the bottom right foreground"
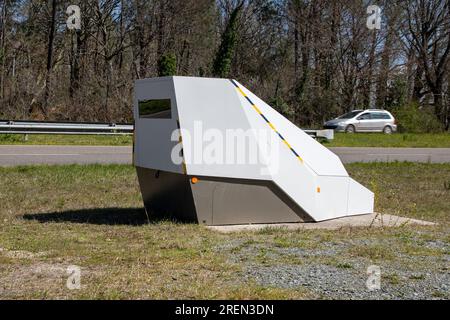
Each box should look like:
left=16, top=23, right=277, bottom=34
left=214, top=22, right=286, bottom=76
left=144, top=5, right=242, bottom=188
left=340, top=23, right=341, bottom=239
left=245, top=265, right=450, bottom=300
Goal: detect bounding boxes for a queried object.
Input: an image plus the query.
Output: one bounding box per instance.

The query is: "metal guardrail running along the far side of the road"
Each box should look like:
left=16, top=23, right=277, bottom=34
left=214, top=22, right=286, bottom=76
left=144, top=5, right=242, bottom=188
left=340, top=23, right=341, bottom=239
left=0, top=120, right=334, bottom=140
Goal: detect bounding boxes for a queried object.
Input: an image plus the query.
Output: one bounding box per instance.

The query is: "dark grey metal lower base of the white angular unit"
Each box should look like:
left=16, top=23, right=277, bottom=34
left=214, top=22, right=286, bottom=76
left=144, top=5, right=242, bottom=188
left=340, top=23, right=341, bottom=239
left=137, top=167, right=312, bottom=225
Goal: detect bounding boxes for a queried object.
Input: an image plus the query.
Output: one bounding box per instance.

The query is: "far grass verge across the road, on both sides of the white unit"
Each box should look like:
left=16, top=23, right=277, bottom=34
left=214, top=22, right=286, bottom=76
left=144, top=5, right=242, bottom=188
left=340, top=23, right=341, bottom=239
left=0, top=133, right=450, bottom=148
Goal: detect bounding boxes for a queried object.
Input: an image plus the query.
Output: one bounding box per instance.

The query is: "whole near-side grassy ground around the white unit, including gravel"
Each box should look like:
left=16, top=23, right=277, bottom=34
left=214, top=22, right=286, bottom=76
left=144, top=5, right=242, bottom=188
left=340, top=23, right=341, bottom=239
left=0, top=163, right=450, bottom=299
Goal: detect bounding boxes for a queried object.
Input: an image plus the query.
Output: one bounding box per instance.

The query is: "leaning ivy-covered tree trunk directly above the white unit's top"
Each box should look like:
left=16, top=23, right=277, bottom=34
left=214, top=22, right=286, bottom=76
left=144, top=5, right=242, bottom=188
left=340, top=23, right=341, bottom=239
left=212, top=2, right=243, bottom=78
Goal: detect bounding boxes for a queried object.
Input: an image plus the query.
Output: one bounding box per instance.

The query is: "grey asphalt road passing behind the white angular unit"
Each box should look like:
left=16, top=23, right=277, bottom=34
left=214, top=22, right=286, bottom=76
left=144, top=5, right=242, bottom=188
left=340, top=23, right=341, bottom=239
left=0, top=145, right=450, bottom=166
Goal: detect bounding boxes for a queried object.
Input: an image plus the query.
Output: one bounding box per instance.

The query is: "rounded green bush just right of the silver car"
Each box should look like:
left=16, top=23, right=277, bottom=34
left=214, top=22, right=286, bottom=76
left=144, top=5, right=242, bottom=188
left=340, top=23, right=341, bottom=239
left=393, top=103, right=443, bottom=133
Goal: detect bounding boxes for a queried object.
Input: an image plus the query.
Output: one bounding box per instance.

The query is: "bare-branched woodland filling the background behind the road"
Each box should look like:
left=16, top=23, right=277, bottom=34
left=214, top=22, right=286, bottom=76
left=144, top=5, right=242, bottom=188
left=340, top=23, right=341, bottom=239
left=0, top=0, right=450, bottom=132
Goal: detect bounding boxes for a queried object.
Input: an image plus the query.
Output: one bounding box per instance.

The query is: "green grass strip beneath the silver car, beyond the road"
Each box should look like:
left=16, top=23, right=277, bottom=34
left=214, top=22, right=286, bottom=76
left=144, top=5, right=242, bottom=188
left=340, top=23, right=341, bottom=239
left=325, top=133, right=450, bottom=148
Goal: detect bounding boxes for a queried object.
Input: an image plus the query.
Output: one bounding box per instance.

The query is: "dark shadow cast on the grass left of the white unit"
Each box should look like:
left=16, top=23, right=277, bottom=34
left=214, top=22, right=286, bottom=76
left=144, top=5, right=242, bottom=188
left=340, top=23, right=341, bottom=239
left=23, top=208, right=185, bottom=226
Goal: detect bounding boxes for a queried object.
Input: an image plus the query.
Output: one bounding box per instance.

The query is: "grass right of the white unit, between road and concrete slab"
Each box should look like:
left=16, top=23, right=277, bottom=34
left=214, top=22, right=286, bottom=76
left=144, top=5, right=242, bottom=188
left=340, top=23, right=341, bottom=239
left=348, top=162, right=450, bottom=223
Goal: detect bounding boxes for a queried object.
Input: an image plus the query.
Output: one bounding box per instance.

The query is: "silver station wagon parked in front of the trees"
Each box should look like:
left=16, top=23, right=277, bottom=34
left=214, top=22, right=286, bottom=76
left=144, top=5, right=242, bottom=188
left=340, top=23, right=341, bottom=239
left=324, top=109, right=397, bottom=134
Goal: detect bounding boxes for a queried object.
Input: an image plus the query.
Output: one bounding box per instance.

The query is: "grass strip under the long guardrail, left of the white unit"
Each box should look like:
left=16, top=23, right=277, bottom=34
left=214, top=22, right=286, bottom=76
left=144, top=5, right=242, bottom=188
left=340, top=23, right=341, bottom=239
left=0, top=134, right=133, bottom=146
